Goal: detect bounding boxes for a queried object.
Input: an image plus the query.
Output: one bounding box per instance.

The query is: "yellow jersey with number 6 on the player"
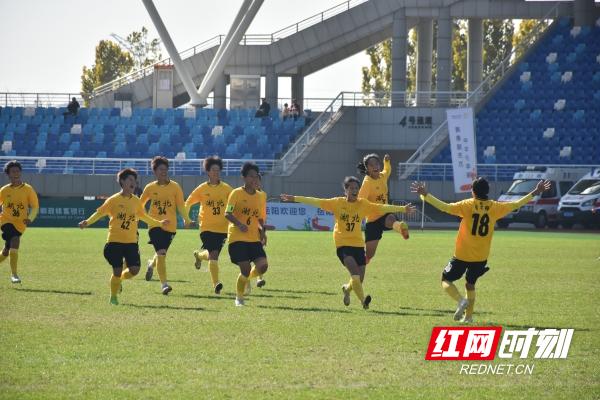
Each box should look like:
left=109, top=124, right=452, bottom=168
left=227, top=187, right=266, bottom=243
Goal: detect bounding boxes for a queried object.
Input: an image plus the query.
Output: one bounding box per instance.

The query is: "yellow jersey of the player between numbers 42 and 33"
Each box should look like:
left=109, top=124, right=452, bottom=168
left=140, top=180, right=189, bottom=233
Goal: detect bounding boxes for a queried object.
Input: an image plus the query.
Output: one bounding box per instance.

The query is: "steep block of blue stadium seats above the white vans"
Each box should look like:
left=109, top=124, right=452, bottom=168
left=432, top=19, right=600, bottom=164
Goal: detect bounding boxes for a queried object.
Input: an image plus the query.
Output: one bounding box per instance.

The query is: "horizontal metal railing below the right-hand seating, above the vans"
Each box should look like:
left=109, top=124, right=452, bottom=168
left=398, top=163, right=600, bottom=182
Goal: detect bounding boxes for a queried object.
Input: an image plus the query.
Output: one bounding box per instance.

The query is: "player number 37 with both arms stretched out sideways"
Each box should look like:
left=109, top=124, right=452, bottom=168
left=281, top=176, right=414, bottom=309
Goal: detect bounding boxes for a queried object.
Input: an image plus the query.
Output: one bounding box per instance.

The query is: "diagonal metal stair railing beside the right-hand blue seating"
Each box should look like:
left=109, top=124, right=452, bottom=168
left=404, top=3, right=559, bottom=177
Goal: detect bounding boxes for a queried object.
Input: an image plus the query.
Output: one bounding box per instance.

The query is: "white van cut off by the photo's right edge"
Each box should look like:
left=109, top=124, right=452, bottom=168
left=558, top=168, right=600, bottom=229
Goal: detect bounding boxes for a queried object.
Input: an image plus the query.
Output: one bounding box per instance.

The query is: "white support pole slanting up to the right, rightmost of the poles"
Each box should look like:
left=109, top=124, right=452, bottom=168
left=198, top=0, right=264, bottom=104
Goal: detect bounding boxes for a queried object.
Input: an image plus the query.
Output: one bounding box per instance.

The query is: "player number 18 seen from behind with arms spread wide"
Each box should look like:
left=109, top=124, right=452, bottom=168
left=411, top=177, right=550, bottom=323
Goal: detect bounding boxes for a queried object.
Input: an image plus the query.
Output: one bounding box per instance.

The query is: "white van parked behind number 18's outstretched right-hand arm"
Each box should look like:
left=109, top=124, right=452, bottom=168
left=498, top=166, right=589, bottom=228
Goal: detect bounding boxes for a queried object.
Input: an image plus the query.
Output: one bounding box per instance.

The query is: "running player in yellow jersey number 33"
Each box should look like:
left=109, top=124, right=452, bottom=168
left=185, top=156, right=233, bottom=294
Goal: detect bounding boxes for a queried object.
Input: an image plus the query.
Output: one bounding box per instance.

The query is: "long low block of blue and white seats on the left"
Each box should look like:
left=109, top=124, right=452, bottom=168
left=0, top=107, right=305, bottom=159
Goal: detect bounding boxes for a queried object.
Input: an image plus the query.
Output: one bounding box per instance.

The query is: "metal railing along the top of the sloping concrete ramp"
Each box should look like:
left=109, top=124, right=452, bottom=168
left=91, top=0, right=367, bottom=98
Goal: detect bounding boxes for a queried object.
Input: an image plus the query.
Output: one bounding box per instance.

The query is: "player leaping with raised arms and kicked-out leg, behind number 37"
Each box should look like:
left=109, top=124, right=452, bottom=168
left=357, top=154, right=408, bottom=264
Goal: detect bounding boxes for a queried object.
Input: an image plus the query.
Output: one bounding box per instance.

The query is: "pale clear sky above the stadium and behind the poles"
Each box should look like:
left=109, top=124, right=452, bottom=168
left=0, top=0, right=369, bottom=98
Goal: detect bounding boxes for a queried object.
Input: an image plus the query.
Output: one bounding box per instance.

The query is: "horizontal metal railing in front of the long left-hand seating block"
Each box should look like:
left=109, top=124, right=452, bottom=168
left=0, top=156, right=275, bottom=176
